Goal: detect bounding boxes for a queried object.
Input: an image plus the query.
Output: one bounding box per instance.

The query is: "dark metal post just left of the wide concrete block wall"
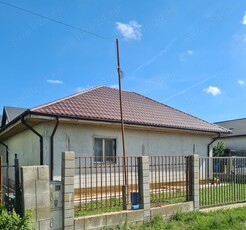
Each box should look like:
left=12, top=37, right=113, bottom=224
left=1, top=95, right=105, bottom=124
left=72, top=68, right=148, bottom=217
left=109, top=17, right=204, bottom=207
left=14, top=154, right=22, bottom=215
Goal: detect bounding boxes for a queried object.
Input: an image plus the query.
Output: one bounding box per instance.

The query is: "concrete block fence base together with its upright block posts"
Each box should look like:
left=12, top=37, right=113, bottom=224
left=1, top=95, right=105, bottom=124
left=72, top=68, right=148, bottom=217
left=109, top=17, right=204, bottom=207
left=21, top=151, right=202, bottom=230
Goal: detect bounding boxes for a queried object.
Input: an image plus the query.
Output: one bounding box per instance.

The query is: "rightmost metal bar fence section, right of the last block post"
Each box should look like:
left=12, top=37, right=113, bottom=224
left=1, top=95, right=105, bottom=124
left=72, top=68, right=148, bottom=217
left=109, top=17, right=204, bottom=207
left=199, top=157, right=246, bottom=208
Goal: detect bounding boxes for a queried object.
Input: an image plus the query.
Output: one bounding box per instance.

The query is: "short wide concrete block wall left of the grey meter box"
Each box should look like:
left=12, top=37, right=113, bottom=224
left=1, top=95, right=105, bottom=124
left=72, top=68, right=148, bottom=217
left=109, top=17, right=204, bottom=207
left=21, top=166, right=50, bottom=229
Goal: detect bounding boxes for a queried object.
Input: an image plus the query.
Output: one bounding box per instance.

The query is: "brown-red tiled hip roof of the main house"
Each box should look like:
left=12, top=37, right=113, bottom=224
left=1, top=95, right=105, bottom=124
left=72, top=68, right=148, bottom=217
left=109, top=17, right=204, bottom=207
left=31, top=86, right=228, bottom=133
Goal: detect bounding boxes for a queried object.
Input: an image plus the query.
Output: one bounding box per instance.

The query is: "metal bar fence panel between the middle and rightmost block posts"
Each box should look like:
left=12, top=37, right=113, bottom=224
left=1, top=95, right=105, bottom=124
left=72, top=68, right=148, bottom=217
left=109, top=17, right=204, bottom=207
left=150, top=156, right=191, bottom=206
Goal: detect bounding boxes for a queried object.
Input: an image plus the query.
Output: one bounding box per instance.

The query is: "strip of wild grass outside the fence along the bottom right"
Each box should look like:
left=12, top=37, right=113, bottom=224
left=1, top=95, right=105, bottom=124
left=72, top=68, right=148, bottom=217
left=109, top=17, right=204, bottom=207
left=108, top=208, right=246, bottom=230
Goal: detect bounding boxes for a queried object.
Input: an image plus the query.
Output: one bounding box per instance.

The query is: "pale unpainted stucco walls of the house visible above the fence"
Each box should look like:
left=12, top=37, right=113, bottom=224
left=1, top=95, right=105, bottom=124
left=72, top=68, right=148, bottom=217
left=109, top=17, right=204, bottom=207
left=1, top=123, right=212, bottom=180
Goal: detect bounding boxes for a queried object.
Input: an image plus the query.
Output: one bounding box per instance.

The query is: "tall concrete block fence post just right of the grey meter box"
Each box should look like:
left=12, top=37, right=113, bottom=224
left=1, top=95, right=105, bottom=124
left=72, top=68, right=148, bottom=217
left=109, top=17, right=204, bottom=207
left=61, top=151, right=75, bottom=229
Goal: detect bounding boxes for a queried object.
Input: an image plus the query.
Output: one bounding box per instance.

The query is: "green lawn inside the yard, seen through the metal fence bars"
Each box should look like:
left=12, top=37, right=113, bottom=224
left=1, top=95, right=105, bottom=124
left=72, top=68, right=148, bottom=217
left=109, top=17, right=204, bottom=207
left=75, top=183, right=246, bottom=217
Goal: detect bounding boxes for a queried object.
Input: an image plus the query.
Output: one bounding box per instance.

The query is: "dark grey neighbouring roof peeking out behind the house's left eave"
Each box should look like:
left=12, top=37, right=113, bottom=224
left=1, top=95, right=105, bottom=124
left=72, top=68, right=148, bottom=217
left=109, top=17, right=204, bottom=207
left=1, top=106, right=27, bottom=127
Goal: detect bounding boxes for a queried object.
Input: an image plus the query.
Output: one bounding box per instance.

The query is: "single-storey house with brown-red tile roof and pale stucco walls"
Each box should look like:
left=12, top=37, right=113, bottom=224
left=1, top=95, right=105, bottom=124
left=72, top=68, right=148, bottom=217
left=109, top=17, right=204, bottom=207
left=0, top=86, right=229, bottom=180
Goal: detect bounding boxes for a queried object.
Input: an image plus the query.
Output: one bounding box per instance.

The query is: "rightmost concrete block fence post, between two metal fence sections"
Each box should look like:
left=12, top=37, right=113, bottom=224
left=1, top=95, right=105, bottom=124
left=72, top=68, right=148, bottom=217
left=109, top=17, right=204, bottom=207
left=191, top=154, right=200, bottom=211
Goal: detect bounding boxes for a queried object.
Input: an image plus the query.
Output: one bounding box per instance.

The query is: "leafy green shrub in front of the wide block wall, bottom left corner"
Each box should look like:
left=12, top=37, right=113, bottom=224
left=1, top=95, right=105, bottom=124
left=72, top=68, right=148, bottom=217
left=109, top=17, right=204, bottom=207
left=0, top=207, right=32, bottom=230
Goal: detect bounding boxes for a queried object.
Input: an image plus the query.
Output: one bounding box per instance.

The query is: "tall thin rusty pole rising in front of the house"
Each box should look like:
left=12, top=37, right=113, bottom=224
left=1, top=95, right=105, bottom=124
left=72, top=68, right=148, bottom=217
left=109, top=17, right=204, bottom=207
left=116, top=38, right=127, bottom=207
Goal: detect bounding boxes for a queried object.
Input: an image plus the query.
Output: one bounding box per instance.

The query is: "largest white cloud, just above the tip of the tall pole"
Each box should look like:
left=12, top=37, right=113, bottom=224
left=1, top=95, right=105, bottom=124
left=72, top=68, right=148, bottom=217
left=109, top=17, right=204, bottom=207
left=116, top=21, right=142, bottom=40
